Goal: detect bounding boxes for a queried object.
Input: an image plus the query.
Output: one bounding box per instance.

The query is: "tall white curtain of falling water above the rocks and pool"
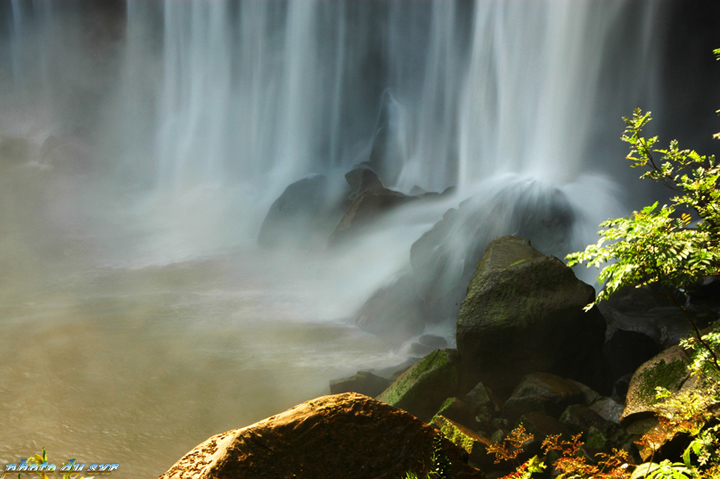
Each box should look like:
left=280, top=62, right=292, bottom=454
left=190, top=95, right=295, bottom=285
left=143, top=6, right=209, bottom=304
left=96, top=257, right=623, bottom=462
left=0, top=0, right=708, bottom=262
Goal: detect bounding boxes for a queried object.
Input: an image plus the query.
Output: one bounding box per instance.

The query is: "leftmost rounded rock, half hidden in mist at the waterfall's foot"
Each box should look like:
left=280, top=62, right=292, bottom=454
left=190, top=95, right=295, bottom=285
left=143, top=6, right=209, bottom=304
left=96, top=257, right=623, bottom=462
left=258, top=175, right=344, bottom=247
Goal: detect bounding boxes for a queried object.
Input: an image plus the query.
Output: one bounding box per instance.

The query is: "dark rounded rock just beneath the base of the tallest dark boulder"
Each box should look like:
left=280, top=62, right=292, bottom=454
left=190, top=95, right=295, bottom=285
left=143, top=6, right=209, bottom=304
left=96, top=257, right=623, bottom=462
left=502, top=373, right=583, bottom=420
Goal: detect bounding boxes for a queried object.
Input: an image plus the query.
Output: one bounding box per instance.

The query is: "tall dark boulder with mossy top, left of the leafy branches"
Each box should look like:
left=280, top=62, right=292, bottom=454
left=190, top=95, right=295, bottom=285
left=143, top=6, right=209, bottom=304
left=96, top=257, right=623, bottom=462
left=457, top=236, right=605, bottom=397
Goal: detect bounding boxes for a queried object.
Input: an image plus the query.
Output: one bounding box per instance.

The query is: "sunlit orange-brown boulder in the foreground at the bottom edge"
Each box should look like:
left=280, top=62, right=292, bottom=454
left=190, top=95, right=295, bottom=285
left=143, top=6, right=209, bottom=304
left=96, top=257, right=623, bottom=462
left=160, top=393, right=483, bottom=479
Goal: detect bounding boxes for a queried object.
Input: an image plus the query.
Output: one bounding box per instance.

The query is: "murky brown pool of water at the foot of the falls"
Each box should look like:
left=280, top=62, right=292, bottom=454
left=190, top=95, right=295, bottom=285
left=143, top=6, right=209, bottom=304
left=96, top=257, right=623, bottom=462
left=0, top=164, right=402, bottom=478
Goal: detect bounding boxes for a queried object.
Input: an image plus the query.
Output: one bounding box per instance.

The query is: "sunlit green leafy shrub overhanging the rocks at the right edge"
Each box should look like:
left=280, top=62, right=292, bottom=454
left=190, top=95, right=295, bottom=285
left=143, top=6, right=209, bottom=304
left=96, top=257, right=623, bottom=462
left=567, top=105, right=720, bottom=373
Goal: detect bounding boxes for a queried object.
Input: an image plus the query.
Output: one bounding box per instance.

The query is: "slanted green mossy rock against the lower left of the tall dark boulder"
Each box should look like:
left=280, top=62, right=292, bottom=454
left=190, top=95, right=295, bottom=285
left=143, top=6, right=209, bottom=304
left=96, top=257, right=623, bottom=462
left=377, top=349, right=459, bottom=420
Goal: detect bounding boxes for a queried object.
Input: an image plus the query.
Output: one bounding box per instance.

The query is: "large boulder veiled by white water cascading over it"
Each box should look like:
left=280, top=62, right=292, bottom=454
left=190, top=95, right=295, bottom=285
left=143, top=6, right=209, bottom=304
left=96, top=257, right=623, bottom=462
left=348, top=178, right=577, bottom=339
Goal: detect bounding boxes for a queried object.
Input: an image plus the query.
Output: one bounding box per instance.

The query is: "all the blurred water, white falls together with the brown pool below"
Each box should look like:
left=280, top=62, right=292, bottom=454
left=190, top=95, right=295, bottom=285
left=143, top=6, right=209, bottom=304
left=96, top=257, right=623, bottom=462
left=0, top=0, right=717, bottom=477
